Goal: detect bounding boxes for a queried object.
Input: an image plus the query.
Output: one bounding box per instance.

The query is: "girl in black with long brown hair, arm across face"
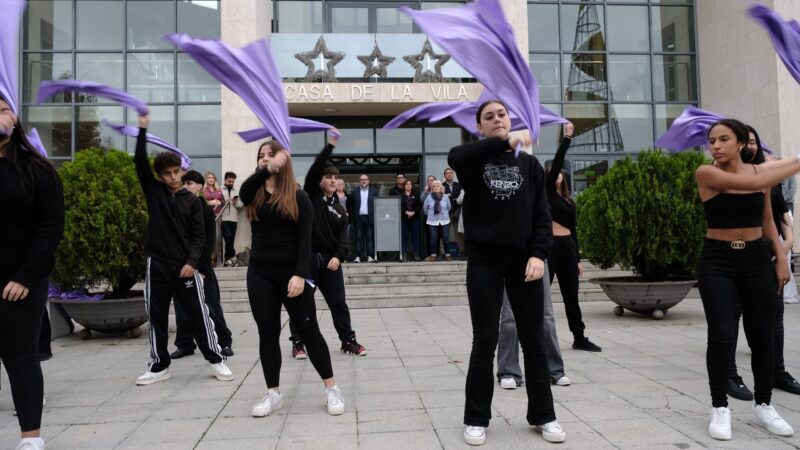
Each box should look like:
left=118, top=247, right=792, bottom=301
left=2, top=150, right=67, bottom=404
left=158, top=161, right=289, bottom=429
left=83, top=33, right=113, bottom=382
left=239, top=141, right=344, bottom=417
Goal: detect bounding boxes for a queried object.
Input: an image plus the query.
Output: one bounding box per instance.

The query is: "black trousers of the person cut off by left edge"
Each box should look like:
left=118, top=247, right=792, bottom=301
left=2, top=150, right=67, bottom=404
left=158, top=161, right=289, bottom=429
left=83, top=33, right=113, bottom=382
left=0, top=277, right=47, bottom=432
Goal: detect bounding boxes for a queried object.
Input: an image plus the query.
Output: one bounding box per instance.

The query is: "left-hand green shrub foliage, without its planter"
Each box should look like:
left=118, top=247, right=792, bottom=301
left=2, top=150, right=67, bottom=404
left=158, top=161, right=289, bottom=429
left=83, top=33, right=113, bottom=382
left=53, top=148, right=147, bottom=298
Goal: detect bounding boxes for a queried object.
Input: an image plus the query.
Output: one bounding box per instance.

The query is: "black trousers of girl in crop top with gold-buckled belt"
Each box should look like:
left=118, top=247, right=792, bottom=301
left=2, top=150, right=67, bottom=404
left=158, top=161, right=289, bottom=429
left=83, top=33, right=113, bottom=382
left=699, top=239, right=778, bottom=408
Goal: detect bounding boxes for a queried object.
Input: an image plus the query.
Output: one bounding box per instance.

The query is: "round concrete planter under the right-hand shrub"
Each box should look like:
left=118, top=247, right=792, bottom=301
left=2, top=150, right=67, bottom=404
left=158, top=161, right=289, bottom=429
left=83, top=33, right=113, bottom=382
left=589, top=277, right=697, bottom=320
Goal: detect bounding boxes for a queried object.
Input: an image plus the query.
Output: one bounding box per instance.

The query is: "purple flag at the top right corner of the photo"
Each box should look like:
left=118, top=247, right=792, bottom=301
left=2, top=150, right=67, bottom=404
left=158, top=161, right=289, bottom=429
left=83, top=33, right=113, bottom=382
left=747, top=5, right=800, bottom=83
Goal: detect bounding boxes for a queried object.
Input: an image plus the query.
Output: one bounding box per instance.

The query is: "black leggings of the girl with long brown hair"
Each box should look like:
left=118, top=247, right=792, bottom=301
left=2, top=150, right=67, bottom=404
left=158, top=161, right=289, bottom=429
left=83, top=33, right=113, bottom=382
left=247, top=261, right=333, bottom=388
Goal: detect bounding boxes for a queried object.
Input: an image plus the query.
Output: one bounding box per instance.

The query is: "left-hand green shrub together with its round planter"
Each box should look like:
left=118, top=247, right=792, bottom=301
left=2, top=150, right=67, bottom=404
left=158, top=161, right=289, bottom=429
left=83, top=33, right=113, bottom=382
left=50, top=148, right=148, bottom=338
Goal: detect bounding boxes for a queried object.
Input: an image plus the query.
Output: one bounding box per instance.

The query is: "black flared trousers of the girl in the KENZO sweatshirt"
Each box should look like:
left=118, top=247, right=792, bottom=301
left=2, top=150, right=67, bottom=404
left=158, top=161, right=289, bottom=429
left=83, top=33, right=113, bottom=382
left=464, top=244, right=556, bottom=427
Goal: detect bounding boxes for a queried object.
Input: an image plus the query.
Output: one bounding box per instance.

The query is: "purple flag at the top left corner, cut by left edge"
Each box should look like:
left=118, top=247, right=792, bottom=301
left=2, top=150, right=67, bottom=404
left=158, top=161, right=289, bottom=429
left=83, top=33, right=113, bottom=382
left=0, top=0, right=25, bottom=115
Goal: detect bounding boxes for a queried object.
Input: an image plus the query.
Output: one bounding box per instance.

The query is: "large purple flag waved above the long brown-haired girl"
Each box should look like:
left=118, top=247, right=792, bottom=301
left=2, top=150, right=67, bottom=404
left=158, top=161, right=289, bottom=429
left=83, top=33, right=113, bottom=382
left=165, top=34, right=291, bottom=149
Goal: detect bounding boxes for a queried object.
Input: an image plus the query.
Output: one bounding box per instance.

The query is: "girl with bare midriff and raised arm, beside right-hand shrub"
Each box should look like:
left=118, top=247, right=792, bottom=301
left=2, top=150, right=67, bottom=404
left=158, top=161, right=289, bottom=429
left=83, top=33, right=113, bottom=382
left=545, top=123, right=602, bottom=352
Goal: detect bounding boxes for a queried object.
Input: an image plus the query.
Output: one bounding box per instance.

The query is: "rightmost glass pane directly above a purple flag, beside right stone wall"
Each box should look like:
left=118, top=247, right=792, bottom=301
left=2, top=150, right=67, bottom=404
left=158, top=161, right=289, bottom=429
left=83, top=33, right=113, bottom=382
left=653, top=55, right=697, bottom=102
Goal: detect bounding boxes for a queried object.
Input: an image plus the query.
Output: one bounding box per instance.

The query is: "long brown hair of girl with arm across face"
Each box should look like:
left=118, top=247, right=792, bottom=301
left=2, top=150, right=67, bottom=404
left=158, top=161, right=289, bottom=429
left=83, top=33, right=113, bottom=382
left=245, top=140, right=300, bottom=222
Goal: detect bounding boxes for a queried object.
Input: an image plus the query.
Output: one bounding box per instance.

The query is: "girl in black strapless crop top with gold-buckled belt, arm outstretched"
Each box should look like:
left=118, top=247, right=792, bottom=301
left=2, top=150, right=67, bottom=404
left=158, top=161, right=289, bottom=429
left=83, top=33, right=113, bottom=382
left=695, top=119, right=800, bottom=440
